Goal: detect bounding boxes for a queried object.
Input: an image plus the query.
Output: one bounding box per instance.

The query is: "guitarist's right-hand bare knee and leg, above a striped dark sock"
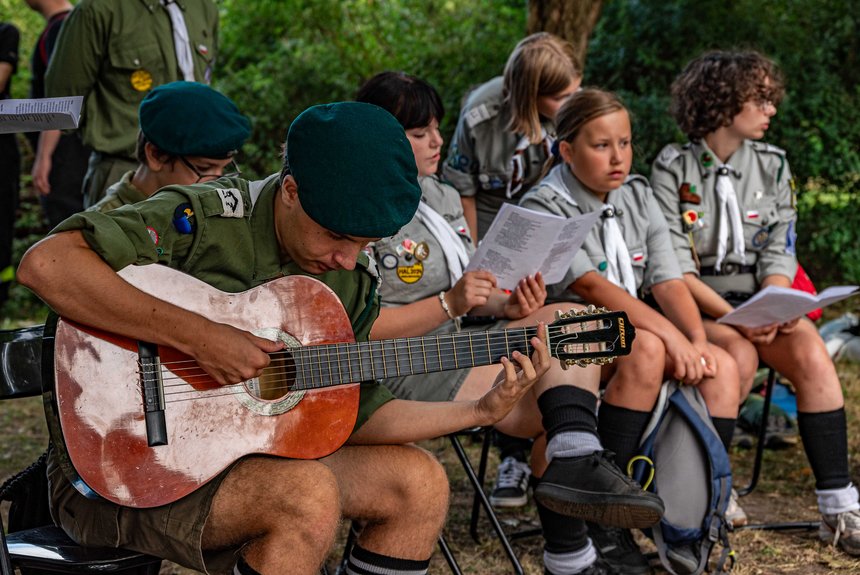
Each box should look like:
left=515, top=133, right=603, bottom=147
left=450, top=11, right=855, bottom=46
left=321, top=445, right=448, bottom=560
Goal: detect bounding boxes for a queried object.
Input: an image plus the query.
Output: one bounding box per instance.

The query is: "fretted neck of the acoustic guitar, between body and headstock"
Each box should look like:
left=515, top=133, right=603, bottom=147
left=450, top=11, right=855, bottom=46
left=292, top=327, right=537, bottom=389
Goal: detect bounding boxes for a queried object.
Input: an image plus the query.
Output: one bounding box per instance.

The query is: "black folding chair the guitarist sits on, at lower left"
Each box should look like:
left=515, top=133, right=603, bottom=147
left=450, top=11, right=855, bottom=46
left=0, top=326, right=161, bottom=575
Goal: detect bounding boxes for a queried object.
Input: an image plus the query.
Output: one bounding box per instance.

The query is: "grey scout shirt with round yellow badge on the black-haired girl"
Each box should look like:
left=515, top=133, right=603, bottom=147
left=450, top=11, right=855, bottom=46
left=369, top=176, right=475, bottom=306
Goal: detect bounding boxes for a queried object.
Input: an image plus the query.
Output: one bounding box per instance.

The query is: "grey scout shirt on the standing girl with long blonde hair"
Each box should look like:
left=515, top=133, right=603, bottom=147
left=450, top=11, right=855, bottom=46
left=442, top=76, right=555, bottom=238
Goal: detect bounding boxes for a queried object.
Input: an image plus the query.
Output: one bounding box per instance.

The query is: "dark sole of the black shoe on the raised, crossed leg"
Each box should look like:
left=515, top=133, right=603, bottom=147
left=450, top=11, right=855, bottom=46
left=534, top=483, right=664, bottom=529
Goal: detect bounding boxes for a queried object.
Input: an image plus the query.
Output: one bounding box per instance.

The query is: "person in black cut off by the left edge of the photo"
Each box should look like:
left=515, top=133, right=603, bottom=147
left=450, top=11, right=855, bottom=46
left=0, top=22, right=21, bottom=306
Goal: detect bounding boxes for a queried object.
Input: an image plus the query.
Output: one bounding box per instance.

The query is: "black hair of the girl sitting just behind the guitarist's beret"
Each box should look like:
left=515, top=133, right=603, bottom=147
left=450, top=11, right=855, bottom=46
left=355, top=71, right=445, bottom=130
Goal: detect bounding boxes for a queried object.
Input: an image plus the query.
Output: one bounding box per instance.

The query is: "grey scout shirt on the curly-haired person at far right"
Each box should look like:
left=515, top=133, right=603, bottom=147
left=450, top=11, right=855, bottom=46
left=651, top=140, right=797, bottom=294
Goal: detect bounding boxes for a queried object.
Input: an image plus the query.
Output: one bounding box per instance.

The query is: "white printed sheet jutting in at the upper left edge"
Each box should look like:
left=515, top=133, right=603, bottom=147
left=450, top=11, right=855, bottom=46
left=0, top=96, right=84, bottom=134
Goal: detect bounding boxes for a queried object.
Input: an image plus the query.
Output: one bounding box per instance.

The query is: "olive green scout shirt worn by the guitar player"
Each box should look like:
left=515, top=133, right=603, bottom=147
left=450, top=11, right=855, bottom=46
left=54, top=174, right=392, bottom=429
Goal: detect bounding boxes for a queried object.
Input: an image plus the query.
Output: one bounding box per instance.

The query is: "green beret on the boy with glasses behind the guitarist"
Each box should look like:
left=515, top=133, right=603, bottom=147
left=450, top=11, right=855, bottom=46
left=139, top=82, right=251, bottom=158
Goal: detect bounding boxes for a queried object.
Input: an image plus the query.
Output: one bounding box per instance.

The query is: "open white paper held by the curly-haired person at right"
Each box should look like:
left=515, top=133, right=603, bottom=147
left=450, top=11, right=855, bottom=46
left=717, top=286, right=860, bottom=327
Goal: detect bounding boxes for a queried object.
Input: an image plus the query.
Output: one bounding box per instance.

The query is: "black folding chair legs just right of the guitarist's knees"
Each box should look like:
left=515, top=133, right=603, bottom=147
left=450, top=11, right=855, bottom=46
left=448, top=427, right=541, bottom=575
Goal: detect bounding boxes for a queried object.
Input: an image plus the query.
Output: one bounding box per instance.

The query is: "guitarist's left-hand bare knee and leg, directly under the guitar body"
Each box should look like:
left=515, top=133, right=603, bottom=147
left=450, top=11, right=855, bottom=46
left=203, top=457, right=340, bottom=575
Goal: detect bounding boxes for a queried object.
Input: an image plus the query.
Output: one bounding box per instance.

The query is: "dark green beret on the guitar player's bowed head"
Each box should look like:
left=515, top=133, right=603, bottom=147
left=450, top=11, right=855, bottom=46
left=287, top=102, right=421, bottom=238
